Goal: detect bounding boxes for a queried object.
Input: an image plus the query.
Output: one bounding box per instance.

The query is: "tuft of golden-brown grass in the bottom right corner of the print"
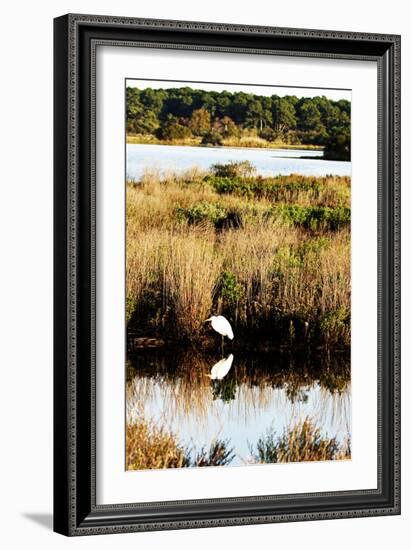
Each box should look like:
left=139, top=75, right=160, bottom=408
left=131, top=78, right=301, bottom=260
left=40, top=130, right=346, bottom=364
left=250, top=417, right=351, bottom=463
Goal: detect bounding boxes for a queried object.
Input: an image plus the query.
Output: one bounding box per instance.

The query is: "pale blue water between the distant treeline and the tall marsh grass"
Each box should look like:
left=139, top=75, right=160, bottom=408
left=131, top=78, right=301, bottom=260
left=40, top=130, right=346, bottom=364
left=126, top=143, right=351, bottom=180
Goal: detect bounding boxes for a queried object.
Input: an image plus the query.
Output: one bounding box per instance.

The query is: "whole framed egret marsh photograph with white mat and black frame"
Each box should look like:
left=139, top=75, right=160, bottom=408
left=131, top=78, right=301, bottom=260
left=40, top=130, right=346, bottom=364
left=54, top=15, right=400, bottom=536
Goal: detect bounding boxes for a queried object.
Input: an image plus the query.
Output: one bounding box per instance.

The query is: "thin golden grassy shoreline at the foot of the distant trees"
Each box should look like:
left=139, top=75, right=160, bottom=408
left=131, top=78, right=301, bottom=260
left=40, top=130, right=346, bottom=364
left=126, top=134, right=324, bottom=151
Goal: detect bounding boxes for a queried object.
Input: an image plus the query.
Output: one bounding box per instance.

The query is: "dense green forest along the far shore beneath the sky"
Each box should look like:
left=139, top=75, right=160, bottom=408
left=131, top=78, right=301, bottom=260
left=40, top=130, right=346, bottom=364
left=126, top=87, right=351, bottom=160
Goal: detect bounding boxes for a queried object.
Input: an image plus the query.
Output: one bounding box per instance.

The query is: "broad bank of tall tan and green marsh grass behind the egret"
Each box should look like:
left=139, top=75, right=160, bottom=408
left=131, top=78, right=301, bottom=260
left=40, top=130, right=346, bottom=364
left=126, top=163, right=350, bottom=348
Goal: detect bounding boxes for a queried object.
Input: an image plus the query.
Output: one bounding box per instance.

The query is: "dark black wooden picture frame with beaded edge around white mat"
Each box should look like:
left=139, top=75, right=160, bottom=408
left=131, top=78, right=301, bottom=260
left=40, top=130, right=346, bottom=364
left=54, top=15, right=400, bottom=535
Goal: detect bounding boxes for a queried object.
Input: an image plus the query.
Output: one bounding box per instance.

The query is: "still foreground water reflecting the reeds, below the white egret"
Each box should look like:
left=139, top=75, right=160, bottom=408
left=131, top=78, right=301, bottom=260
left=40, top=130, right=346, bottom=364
left=126, top=350, right=351, bottom=465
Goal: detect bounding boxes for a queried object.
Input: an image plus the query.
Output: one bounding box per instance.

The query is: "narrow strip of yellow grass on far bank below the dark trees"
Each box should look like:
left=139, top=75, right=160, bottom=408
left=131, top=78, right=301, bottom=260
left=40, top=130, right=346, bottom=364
left=126, top=134, right=324, bottom=151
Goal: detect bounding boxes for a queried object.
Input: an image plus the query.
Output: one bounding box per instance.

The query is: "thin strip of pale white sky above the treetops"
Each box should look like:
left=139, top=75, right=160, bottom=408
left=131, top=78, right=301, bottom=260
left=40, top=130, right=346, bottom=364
left=126, top=79, right=351, bottom=101
